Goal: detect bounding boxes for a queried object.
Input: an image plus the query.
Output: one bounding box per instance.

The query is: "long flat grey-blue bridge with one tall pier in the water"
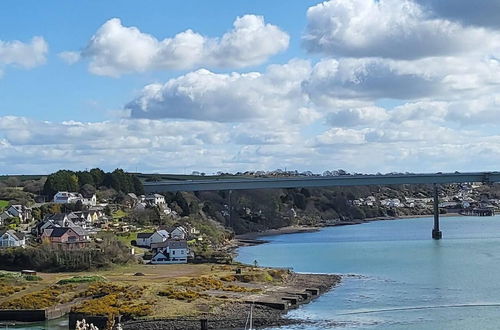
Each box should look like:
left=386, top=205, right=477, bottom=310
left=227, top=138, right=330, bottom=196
left=144, top=172, right=500, bottom=239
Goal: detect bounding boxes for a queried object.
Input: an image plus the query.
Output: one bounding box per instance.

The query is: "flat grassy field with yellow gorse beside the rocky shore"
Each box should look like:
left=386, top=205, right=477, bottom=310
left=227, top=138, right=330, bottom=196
left=0, top=264, right=288, bottom=318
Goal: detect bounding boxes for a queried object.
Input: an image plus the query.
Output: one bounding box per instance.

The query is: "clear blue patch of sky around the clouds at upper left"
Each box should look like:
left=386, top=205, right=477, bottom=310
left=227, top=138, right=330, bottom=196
left=0, top=1, right=315, bottom=121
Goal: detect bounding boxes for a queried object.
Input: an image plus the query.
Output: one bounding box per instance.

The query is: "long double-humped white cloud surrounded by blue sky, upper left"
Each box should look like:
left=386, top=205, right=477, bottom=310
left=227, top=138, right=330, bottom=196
left=70, top=15, right=289, bottom=77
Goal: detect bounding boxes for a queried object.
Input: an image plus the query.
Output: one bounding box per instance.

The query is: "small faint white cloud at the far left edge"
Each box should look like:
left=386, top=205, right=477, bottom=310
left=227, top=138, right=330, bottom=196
left=0, top=37, right=49, bottom=73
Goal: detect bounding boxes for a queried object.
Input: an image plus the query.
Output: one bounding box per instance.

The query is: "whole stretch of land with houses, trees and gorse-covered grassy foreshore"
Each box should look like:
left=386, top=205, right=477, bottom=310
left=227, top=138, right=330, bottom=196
left=0, top=168, right=500, bottom=329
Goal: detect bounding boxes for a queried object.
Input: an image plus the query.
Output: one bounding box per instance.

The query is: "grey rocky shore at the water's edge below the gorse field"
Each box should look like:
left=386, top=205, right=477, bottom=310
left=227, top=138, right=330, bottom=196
left=123, top=273, right=341, bottom=330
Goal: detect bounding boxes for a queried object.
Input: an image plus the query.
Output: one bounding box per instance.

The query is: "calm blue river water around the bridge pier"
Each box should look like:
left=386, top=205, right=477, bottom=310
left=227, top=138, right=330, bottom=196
left=238, top=216, right=500, bottom=330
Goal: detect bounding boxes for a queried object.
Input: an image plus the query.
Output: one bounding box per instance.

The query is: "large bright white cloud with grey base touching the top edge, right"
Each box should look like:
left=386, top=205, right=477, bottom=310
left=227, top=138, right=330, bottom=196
left=303, top=0, right=498, bottom=59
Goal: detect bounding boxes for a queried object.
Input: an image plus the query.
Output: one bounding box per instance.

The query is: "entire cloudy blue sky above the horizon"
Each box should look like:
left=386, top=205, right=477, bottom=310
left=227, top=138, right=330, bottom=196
left=0, top=0, right=500, bottom=174
